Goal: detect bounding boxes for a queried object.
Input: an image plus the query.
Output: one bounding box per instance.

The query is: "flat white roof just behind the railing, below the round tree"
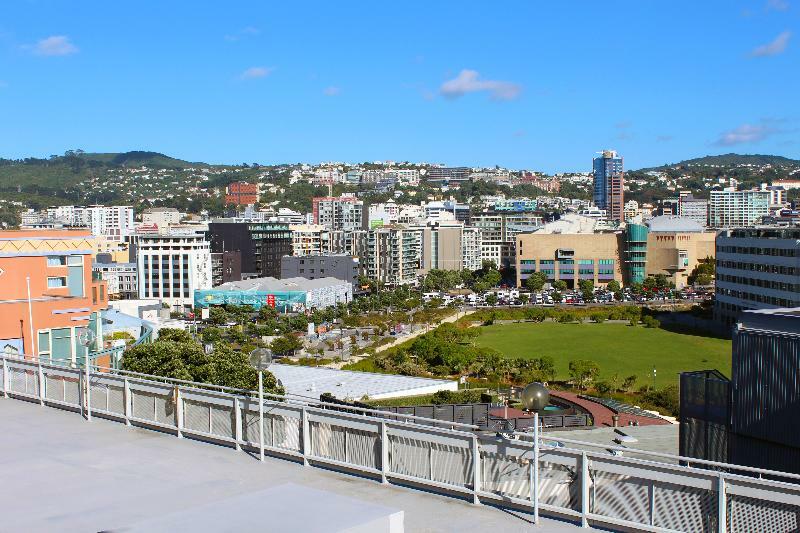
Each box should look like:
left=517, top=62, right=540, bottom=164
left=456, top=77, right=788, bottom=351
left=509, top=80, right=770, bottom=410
left=269, top=363, right=458, bottom=400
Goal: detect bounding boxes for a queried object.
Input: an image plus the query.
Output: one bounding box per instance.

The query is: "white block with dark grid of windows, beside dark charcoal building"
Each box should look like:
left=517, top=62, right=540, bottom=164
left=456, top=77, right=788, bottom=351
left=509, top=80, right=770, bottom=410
left=137, top=233, right=212, bottom=311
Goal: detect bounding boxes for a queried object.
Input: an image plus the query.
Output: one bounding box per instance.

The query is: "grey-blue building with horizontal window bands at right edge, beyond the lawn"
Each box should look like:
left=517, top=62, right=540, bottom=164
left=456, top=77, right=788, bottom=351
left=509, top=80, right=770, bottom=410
left=714, top=226, right=800, bottom=325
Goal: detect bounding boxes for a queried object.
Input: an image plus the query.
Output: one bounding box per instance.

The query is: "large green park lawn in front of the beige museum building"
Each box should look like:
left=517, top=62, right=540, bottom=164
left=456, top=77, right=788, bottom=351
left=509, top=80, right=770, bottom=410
left=475, top=322, right=731, bottom=388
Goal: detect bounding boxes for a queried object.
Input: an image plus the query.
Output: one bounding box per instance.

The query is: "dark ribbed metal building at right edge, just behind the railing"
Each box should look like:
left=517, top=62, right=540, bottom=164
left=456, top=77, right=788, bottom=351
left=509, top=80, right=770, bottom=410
left=680, top=308, right=800, bottom=473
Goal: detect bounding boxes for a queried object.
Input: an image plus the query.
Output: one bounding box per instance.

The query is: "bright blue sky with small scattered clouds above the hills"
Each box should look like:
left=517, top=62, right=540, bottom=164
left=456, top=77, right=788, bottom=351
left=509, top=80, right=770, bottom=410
left=0, top=0, right=800, bottom=172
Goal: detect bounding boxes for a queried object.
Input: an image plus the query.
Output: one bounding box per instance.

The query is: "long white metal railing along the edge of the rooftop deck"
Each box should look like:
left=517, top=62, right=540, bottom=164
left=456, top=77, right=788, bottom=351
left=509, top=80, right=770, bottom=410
left=0, top=357, right=800, bottom=532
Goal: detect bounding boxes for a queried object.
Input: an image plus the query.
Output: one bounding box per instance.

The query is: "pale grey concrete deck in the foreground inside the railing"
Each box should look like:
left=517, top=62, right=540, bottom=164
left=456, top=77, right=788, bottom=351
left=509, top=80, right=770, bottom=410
left=0, top=398, right=586, bottom=533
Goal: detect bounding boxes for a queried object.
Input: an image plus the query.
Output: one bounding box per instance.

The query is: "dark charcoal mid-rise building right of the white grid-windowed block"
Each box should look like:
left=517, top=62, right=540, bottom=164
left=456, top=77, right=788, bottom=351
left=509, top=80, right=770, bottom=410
left=208, top=222, right=292, bottom=278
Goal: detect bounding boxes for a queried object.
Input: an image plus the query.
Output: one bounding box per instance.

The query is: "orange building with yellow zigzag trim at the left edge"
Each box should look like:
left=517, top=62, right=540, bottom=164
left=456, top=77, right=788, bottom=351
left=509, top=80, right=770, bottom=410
left=0, top=229, right=108, bottom=361
